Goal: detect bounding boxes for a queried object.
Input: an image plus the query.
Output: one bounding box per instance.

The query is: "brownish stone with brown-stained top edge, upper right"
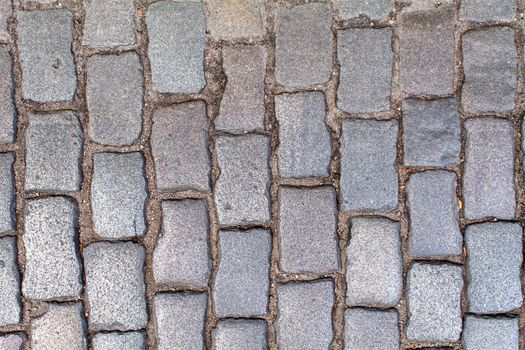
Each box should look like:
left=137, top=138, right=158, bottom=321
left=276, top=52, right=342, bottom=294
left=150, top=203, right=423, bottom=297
left=399, top=8, right=455, bottom=95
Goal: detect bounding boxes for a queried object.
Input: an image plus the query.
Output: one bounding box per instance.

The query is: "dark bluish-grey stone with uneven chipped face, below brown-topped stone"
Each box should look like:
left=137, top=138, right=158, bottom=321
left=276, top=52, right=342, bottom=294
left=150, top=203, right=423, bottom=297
left=403, top=99, right=461, bottom=167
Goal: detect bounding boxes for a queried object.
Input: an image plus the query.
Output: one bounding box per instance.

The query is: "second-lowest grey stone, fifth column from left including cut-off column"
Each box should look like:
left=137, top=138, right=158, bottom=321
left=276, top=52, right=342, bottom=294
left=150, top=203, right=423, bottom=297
left=213, top=229, right=272, bottom=317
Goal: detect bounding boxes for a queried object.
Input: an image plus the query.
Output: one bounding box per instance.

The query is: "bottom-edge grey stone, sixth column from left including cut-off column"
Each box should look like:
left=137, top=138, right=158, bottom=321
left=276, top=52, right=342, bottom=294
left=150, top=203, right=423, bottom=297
left=275, top=280, right=335, bottom=350
